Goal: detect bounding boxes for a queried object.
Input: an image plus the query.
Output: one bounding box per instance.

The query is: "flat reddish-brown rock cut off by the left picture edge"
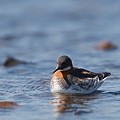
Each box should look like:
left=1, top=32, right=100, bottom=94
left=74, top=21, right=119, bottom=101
left=0, top=101, right=18, bottom=109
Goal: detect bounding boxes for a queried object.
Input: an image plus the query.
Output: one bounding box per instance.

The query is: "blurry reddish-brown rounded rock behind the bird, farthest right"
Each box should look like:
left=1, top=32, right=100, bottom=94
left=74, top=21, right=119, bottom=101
left=96, top=41, right=117, bottom=50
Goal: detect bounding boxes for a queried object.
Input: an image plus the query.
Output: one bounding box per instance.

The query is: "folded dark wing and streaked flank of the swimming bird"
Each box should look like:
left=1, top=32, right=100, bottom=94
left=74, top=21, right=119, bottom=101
left=72, top=68, right=110, bottom=90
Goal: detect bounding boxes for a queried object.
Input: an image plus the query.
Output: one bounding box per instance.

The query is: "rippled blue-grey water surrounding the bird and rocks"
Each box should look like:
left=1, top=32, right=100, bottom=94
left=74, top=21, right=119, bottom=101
left=0, top=0, right=120, bottom=120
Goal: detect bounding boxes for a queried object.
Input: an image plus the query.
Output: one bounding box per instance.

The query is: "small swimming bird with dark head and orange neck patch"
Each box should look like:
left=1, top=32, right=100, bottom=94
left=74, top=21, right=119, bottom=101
left=50, top=55, right=111, bottom=94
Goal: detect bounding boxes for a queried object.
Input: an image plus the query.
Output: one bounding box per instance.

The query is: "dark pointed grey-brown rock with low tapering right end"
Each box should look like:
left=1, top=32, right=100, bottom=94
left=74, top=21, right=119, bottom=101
left=3, top=57, right=26, bottom=67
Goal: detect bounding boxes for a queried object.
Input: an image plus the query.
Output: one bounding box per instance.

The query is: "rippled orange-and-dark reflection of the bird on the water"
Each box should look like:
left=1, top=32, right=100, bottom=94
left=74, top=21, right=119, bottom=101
left=51, top=91, right=101, bottom=114
